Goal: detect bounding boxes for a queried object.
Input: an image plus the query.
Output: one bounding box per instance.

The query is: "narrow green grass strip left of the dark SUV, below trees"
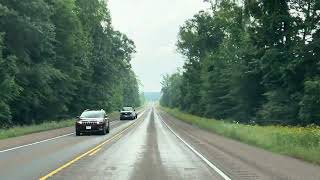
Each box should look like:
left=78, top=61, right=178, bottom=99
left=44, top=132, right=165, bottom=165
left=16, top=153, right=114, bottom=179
left=0, top=119, right=75, bottom=140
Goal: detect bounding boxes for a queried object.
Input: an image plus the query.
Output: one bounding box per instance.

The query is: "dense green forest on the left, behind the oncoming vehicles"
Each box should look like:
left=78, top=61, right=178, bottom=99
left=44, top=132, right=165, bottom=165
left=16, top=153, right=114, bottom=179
left=0, top=0, right=140, bottom=128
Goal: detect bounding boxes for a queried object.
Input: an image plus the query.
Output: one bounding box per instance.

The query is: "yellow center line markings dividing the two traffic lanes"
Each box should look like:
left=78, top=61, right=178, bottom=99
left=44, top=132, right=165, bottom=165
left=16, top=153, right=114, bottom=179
left=39, top=109, right=148, bottom=180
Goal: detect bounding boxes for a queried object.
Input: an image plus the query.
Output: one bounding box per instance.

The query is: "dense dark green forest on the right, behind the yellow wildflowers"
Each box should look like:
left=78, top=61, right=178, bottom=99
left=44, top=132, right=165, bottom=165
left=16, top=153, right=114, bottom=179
left=161, top=0, right=320, bottom=125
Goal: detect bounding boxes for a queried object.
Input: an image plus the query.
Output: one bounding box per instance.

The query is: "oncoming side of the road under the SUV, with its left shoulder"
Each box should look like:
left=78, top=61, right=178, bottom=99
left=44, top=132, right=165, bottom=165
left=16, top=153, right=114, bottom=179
left=0, top=108, right=148, bottom=180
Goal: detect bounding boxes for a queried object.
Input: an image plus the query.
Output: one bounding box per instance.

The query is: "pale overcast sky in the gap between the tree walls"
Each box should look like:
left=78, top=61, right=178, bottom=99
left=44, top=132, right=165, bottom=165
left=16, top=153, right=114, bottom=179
left=108, top=0, right=208, bottom=91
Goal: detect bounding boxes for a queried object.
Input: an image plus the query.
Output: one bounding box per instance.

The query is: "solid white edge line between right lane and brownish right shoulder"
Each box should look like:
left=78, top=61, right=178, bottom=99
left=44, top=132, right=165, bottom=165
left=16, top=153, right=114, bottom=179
left=156, top=110, right=231, bottom=180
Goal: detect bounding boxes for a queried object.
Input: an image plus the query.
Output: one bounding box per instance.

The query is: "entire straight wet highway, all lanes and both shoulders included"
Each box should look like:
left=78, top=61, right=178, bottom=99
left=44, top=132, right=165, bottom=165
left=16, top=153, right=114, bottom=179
left=0, top=106, right=320, bottom=180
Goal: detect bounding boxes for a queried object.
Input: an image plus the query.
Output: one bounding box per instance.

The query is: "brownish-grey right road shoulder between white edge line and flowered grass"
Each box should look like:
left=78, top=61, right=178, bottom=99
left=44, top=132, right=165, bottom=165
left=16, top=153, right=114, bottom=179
left=159, top=107, right=320, bottom=179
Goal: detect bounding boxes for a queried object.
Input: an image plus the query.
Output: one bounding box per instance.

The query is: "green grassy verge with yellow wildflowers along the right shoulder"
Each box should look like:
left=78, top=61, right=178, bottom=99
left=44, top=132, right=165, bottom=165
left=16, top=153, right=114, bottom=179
left=161, top=107, right=320, bottom=165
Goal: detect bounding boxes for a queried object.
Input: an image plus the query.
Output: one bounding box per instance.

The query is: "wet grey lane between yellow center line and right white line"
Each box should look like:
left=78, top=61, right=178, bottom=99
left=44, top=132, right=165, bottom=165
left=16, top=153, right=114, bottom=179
left=52, top=107, right=222, bottom=180
